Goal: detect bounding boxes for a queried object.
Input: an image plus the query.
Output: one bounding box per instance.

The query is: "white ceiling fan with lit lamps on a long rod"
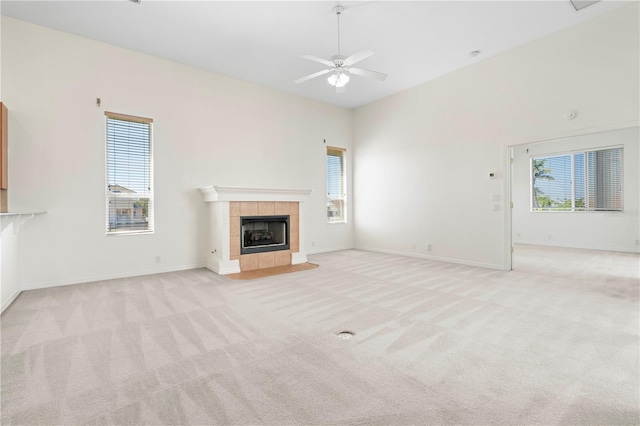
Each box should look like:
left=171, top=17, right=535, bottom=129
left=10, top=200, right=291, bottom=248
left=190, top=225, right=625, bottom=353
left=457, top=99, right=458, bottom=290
left=295, top=5, right=387, bottom=93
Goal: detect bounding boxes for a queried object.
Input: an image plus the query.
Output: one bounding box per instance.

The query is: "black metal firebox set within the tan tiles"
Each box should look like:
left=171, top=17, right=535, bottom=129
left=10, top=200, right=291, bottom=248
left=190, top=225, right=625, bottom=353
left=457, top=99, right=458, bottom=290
left=240, top=216, right=289, bottom=254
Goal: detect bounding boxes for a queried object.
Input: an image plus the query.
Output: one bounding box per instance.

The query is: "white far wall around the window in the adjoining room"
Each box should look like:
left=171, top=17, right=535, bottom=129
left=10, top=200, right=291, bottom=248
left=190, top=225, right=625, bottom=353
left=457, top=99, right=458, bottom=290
left=513, top=127, right=640, bottom=252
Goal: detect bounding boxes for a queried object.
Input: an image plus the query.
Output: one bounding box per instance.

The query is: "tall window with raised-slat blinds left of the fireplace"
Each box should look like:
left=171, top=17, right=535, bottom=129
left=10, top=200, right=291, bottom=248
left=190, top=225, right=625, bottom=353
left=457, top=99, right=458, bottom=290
left=105, top=112, right=153, bottom=235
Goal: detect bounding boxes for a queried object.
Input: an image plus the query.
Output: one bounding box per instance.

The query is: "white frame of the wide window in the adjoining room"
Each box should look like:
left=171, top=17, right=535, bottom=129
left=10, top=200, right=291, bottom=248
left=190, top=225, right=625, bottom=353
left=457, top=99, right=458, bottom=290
left=529, top=145, right=625, bottom=214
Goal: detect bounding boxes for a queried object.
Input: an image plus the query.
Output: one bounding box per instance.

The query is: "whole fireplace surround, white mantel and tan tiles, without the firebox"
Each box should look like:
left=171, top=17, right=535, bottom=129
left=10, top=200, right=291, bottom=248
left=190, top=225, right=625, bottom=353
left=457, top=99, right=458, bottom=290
left=199, top=185, right=313, bottom=275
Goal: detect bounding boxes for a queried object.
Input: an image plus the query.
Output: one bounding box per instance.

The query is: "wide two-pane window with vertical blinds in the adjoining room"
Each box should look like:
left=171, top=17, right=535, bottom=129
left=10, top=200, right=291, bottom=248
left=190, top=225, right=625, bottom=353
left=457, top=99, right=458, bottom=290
left=531, top=148, right=622, bottom=211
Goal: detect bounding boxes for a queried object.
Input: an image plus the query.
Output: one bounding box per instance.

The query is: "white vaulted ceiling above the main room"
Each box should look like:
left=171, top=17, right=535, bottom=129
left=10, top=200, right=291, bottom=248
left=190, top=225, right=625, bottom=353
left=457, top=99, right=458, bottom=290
left=1, top=0, right=625, bottom=108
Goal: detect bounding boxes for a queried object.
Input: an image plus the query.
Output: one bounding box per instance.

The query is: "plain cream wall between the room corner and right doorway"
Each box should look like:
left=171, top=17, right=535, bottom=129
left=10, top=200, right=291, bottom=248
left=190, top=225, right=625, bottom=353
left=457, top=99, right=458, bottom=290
left=354, top=2, right=640, bottom=268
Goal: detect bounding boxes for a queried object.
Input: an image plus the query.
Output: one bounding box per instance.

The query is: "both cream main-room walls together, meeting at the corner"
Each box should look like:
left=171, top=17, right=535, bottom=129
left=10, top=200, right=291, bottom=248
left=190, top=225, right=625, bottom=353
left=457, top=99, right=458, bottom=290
left=1, top=3, right=640, bottom=300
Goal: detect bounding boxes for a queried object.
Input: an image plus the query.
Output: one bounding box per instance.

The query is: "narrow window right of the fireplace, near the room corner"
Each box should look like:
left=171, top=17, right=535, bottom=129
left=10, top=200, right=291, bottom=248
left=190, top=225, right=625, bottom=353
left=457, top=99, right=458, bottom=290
left=327, top=147, right=347, bottom=223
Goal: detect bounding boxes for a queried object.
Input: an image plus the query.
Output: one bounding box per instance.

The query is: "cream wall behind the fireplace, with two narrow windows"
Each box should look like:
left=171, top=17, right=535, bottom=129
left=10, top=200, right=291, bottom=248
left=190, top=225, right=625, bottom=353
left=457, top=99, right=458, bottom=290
left=2, top=17, right=353, bottom=297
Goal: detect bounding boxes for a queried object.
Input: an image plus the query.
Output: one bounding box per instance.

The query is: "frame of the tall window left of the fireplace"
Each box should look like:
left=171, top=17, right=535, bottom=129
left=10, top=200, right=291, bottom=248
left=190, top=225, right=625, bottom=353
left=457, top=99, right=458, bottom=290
left=104, top=111, right=155, bottom=236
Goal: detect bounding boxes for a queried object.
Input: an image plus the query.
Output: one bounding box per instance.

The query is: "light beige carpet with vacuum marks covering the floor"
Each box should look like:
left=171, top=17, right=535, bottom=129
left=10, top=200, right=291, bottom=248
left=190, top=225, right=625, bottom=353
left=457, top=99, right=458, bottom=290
left=1, top=247, right=640, bottom=425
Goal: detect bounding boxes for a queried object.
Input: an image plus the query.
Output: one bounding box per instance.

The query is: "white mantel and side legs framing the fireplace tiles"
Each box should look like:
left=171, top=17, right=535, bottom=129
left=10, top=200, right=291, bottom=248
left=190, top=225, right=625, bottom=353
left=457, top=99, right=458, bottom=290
left=198, top=185, right=313, bottom=275
